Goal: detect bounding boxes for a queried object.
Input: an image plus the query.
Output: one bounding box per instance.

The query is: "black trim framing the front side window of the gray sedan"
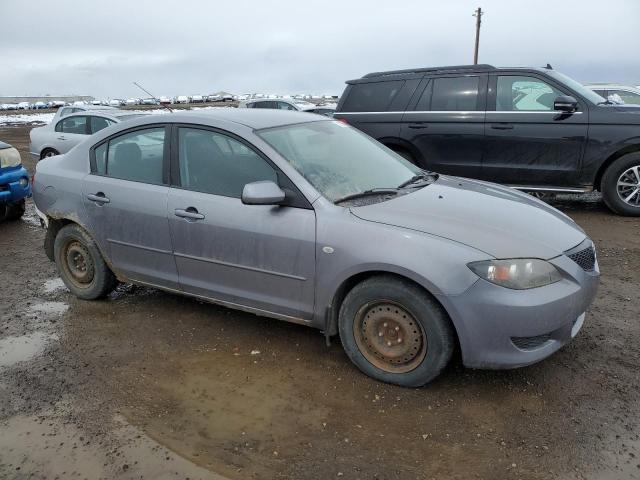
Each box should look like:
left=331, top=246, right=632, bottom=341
left=169, top=123, right=313, bottom=210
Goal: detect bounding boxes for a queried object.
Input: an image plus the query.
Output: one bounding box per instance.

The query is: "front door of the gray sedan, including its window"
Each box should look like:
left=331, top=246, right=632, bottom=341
left=168, top=127, right=316, bottom=320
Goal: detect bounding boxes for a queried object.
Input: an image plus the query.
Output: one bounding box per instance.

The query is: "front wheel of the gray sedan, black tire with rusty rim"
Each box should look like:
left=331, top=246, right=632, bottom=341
left=338, top=276, right=455, bottom=387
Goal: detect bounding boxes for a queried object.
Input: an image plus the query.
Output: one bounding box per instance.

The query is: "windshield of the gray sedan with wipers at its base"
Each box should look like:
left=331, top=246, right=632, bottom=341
left=256, top=121, right=422, bottom=202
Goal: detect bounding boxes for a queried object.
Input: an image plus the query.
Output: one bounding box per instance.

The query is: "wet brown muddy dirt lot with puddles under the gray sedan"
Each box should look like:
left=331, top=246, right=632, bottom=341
left=0, top=127, right=640, bottom=479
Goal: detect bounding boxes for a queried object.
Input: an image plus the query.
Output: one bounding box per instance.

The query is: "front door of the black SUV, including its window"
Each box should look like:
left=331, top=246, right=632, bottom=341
left=482, top=75, right=588, bottom=187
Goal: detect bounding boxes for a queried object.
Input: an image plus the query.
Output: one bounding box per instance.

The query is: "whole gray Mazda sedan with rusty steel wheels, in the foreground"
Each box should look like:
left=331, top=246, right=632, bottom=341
left=34, top=109, right=599, bottom=386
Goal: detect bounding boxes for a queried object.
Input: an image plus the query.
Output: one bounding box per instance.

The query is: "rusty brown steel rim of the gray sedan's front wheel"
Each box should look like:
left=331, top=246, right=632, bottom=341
left=353, top=300, right=427, bottom=373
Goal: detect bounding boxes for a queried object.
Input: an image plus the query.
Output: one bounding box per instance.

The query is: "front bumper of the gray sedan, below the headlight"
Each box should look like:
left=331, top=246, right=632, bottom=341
left=439, top=246, right=600, bottom=369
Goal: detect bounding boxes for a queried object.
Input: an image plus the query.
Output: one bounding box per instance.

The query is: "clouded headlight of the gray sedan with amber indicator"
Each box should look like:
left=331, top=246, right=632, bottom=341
left=467, top=258, right=562, bottom=290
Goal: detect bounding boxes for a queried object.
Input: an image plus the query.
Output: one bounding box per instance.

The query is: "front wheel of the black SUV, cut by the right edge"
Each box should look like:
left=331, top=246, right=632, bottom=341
left=601, top=152, right=640, bottom=216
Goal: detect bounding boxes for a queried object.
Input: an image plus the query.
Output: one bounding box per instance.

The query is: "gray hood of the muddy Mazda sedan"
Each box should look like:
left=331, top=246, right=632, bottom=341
left=351, top=175, right=585, bottom=259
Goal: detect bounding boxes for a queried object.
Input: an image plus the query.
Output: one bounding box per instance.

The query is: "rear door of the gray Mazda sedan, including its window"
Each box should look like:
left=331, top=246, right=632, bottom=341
left=82, top=126, right=179, bottom=289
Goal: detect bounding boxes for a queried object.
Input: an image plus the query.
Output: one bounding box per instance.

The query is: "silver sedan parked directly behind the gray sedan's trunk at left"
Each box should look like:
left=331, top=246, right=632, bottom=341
left=29, top=109, right=145, bottom=160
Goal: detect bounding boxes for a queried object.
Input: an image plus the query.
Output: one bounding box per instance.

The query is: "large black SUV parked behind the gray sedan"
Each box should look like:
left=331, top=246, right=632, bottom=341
left=335, top=65, right=640, bottom=215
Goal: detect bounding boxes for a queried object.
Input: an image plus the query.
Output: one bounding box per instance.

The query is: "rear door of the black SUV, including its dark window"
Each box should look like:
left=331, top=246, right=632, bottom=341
left=400, top=73, right=487, bottom=174
